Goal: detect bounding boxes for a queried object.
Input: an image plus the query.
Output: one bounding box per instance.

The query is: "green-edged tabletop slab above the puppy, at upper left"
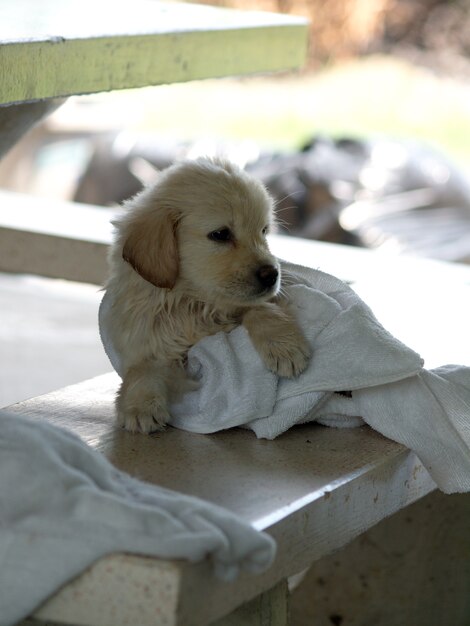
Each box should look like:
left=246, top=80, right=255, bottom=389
left=0, top=0, right=307, bottom=104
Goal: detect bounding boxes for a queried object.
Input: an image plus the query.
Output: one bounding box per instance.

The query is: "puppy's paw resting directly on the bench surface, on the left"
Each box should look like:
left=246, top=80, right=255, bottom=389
left=116, top=397, right=170, bottom=434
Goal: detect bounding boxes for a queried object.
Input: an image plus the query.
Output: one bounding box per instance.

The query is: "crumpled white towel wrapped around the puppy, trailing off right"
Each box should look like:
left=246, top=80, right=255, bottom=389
left=100, top=262, right=470, bottom=493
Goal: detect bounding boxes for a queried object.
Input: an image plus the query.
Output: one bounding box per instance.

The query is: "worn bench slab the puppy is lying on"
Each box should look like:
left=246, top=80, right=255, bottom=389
left=6, top=374, right=434, bottom=626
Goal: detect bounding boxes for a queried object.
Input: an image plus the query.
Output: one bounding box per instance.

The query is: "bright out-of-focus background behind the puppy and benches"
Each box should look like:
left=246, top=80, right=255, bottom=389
left=0, top=0, right=470, bottom=406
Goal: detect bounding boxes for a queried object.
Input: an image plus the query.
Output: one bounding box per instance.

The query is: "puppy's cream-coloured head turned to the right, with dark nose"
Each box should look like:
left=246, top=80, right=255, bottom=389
left=118, top=159, right=280, bottom=304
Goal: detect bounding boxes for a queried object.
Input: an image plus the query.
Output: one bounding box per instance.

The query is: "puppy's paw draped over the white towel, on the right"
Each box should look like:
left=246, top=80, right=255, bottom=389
left=258, top=337, right=310, bottom=378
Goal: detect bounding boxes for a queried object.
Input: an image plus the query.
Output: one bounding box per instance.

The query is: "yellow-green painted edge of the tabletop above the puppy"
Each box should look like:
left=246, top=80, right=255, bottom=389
left=0, top=22, right=308, bottom=104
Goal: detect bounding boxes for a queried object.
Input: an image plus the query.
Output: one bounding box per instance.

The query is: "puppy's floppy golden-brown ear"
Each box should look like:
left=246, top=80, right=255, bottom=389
left=122, top=207, right=178, bottom=289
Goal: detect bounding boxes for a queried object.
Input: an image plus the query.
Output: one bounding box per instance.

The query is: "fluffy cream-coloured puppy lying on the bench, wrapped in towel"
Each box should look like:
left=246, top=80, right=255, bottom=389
left=106, top=159, right=309, bottom=433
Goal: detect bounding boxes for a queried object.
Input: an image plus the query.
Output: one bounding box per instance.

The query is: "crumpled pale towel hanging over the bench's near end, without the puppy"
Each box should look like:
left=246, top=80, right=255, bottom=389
left=0, top=411, right=275, bottom=626
